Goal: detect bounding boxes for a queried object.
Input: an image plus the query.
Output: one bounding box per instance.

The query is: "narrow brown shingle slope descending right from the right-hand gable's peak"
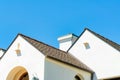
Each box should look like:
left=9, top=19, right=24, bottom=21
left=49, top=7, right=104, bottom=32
left=86, top=28, right=120, bottom=51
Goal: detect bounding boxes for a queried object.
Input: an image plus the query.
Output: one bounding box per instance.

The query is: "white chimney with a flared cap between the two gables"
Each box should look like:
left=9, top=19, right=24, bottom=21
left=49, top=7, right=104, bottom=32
left=58, top=34, right=78, bottom=51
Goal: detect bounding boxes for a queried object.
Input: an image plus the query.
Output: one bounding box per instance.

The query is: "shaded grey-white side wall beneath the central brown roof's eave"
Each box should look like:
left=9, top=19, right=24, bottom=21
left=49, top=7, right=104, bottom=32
left=45, top=58, right=91, bottom=80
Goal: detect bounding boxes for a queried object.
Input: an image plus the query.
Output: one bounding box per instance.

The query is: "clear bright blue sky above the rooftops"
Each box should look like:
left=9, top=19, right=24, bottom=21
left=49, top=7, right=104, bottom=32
left=0, top=0, right=120, bottom=49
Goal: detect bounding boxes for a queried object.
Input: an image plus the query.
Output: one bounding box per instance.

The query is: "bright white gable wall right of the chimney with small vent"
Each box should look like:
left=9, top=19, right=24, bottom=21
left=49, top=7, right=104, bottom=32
left=69, top=30, right=120, bottom=79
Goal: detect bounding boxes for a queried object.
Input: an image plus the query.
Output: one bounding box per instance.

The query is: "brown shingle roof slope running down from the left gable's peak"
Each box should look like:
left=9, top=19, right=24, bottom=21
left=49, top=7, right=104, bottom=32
left=20, top=34, right=93, bottom=73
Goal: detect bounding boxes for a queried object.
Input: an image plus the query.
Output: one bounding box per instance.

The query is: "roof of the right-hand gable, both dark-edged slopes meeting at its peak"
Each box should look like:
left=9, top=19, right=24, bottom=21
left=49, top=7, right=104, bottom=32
left=67, top=28, right=120, bottom=52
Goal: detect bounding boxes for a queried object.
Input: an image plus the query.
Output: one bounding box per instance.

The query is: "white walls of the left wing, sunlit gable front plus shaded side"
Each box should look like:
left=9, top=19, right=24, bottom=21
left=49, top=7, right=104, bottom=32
left=0, top=35, right=92, bottom=80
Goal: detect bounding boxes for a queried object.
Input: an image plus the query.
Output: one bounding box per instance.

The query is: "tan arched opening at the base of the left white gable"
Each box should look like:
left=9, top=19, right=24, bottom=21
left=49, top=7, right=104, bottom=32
left=6, top=66, right=29, bottom=80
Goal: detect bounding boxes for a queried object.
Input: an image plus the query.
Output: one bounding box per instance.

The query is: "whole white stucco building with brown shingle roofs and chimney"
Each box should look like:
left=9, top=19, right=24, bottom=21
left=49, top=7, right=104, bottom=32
left=0, top=29, right=120, bottom=80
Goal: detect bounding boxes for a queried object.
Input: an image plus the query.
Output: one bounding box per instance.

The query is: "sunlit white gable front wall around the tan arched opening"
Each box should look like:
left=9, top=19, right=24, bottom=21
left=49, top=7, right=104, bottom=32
left=0, top=36, right=45, bottom=80
